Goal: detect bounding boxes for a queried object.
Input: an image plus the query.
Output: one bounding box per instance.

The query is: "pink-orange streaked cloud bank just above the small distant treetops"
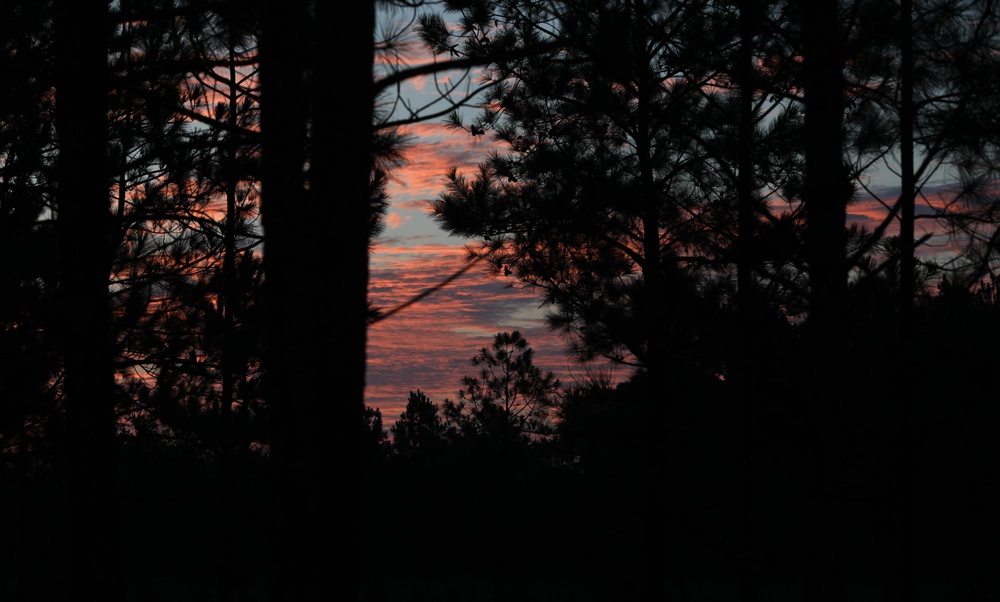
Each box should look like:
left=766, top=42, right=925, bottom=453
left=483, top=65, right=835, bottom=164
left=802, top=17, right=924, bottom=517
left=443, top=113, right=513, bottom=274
left=365, top=244, right=582, bottom=426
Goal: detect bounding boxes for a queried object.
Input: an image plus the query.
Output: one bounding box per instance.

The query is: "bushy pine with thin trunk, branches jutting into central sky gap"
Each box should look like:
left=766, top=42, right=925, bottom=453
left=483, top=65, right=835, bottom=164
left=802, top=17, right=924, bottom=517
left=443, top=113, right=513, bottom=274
left=435, top=2, right=764, bottom=597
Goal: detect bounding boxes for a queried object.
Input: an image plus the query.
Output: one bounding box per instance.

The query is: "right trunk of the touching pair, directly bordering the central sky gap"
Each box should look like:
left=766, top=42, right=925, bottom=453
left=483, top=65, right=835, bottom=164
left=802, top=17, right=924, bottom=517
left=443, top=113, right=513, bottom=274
left=310, top=0, right=375, bottom=599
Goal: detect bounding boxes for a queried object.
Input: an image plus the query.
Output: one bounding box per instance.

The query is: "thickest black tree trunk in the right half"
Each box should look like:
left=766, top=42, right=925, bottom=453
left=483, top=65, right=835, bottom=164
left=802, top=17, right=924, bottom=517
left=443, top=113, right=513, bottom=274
left=799, top=0, right=852, bottom=602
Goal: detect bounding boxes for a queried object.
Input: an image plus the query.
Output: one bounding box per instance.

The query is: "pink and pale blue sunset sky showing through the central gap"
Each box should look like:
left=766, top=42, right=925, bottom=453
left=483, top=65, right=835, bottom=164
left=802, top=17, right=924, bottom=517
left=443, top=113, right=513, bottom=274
left=365, top=11, right=960, bottom=428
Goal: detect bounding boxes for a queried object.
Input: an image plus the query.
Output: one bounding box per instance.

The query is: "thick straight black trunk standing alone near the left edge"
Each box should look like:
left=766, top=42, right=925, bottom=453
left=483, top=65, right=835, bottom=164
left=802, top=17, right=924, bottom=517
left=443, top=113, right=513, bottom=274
left=54, top=0, right=123, bottom=601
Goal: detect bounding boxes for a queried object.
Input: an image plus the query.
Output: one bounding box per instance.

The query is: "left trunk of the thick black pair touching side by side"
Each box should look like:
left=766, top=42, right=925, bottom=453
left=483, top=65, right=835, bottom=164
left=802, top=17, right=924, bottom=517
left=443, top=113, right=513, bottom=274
left=260, top=0, right=308, bottom=602
